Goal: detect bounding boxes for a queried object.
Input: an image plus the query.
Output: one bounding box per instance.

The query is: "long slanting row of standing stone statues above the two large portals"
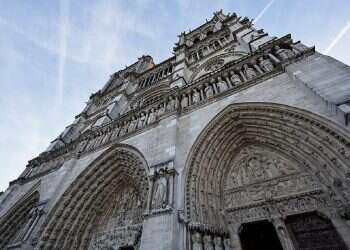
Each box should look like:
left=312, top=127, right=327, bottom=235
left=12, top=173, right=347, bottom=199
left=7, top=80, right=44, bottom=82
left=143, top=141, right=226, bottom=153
left=79, top=45, right=295, bottom=152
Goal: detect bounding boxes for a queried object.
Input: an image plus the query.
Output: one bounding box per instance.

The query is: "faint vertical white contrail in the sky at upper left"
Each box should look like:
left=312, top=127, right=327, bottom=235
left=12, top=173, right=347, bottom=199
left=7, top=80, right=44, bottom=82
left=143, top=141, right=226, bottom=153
left=57, top=0, right=69, bottom=107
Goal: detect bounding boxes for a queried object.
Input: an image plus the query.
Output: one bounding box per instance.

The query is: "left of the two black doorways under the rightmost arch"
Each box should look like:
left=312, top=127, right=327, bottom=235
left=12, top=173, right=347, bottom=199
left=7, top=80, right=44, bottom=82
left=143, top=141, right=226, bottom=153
left=239, top=221, right=283, bottom=250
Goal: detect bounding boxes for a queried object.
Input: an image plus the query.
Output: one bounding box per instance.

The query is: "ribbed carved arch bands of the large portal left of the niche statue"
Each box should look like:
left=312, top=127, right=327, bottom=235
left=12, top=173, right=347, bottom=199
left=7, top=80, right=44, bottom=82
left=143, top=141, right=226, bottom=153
left=39, top=145, right=148, bottom=249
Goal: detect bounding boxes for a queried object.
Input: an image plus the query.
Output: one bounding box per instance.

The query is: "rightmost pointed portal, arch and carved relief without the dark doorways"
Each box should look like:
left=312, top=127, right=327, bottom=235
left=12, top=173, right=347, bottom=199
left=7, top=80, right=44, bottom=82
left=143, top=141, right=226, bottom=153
left=185, top=103, right=350, bottom=249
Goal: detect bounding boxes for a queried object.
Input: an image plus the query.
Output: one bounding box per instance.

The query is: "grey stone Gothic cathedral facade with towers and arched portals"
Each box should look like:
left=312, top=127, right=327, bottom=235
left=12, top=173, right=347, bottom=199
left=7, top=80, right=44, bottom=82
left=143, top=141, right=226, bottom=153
left=0, top=11, right=350, bottom=250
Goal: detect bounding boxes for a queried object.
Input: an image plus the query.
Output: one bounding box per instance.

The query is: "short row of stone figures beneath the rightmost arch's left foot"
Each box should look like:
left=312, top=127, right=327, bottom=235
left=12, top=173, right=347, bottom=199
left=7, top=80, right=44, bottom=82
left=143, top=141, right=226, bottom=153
left=191, top=232, right=233, bottom=250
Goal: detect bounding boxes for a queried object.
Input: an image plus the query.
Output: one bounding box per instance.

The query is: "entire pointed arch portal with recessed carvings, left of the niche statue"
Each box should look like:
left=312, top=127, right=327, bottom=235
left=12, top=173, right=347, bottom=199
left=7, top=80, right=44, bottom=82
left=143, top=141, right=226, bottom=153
left=39, top=145, right=149, bottom=250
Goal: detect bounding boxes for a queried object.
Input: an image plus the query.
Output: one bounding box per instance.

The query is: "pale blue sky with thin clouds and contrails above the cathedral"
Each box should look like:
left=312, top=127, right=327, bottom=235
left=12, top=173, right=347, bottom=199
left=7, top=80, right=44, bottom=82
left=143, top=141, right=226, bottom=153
left=0, top=0, right=350, bottom=190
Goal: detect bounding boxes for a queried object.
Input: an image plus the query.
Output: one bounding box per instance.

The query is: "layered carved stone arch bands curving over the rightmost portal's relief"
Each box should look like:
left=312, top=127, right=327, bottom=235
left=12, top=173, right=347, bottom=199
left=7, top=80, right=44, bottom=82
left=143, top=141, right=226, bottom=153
left=185, top=103, right=350, bottom=231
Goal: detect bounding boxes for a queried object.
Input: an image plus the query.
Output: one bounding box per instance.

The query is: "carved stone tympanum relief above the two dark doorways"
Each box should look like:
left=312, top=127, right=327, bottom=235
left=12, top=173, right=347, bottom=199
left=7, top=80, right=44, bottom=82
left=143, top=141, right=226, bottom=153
left=224, top=146, right=319, bottom=208
